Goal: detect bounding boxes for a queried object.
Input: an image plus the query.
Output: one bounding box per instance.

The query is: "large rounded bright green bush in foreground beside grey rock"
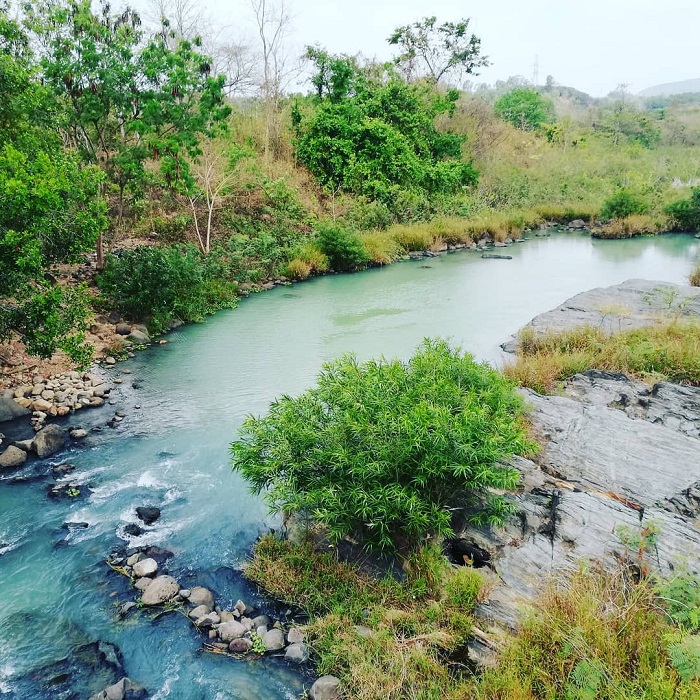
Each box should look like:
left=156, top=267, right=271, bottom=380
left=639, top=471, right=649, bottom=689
left=231, top=340, right=534, bottom=550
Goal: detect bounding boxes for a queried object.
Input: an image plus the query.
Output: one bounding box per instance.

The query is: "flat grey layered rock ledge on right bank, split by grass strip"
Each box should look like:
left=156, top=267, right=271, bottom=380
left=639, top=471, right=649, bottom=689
left=461, top=280, right=700, bottom=663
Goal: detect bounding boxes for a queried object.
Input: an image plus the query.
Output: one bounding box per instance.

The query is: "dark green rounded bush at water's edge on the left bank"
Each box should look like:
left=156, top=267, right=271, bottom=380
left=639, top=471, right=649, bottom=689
left=98, top=246, right=236, bottom=332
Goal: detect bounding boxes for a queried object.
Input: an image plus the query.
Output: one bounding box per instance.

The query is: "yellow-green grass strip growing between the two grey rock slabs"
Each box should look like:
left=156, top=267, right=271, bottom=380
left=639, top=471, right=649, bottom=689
left=504, top=320, right=700, bottom=393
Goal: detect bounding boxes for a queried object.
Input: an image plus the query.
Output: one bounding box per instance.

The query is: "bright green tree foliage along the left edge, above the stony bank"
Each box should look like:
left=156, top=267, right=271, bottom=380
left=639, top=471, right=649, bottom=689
left=0, top=6, right=107, bottom=362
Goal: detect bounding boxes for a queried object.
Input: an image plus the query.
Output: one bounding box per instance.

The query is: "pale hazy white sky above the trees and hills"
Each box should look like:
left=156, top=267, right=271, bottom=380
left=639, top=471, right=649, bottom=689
left=198, top=0, right=700, bottom=96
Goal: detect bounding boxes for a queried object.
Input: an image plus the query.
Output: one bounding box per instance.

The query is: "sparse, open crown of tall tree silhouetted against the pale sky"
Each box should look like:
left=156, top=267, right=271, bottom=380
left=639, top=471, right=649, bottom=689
left=387, top=17, right=489, bottom=83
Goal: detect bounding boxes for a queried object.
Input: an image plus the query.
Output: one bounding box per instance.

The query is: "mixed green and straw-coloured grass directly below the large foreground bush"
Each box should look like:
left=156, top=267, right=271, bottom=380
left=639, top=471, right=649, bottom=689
left=245, top=537, right=484, bottom=700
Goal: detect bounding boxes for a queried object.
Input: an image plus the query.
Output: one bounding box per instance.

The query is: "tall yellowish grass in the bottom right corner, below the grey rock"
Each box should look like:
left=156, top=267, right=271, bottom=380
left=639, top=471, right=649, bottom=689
left=470, top=571, right=700, bottom=700
